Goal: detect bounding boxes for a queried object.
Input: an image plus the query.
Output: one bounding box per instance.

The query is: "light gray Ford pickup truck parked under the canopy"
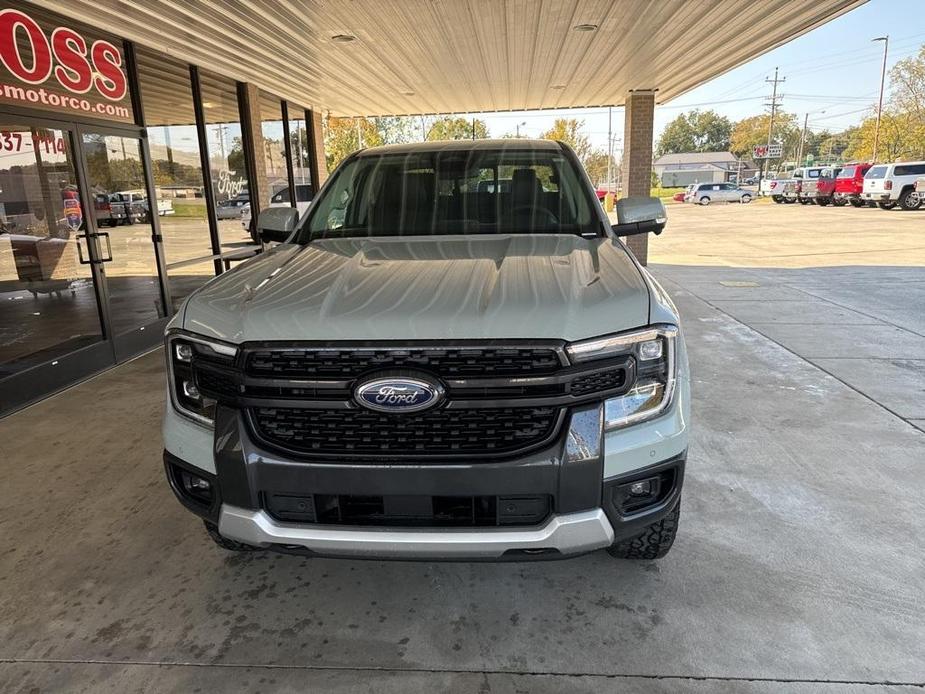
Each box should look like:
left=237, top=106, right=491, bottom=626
left=163, top=140, right=690, bottom=560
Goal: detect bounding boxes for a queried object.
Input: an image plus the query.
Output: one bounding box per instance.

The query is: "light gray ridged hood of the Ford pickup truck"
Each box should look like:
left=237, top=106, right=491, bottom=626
left=182, top=234, right=649, bottom=343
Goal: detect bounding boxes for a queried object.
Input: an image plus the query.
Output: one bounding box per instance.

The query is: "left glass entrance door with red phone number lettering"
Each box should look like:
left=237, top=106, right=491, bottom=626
left=0, top=125, right=102, bottom=378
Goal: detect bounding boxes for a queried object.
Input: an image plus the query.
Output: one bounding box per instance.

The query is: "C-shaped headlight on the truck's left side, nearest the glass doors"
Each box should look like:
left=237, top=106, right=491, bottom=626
left=166, top=331, right=237, bottom=427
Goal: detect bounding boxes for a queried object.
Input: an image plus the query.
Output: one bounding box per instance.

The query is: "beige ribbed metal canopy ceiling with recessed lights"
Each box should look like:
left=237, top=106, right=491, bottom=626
left=36, top=0, right=866, bottom=115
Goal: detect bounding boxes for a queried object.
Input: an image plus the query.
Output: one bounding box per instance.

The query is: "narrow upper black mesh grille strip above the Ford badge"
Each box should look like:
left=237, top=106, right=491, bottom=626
left=246, top=346, right=562, bottom=379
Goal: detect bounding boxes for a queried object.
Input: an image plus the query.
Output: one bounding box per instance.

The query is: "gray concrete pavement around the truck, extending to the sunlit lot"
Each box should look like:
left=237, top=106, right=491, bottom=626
left=0, top=203, right=925, bottom=694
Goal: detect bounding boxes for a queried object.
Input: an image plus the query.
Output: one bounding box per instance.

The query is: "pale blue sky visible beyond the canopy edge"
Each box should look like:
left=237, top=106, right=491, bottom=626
left=456, top=0, right=925, bottom=155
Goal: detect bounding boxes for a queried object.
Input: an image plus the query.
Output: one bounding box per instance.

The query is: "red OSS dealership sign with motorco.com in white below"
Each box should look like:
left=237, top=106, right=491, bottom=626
left=0, top=9, right=132, bottom=121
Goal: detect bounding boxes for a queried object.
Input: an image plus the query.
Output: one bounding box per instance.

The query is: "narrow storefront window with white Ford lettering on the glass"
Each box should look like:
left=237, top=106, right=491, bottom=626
left=200, top=71, right=254, bottom=252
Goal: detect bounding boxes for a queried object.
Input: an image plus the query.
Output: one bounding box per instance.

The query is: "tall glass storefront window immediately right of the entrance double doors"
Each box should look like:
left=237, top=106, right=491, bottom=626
left=136, top=48, right=215, bottom=310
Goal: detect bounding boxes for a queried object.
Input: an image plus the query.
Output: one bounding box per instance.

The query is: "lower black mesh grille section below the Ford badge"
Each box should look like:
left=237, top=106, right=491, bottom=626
left=251, top=407, right=561, bottom=457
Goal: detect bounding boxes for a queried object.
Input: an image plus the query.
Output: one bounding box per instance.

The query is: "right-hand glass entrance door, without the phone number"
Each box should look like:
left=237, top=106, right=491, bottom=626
left=81, top=130, right=167, bottom=359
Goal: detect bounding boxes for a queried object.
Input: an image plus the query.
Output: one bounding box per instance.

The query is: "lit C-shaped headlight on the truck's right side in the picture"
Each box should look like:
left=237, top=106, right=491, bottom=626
left=566, top=325, right=678, bottom=430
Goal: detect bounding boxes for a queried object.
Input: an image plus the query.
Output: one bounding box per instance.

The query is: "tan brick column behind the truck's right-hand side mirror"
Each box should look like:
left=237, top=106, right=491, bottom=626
left=621, top=91, right=655, bottom=265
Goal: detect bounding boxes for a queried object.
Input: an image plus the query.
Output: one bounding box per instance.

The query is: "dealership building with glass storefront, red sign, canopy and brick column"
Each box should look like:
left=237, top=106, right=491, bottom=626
left=0, top=0, right=860, bottom=414
